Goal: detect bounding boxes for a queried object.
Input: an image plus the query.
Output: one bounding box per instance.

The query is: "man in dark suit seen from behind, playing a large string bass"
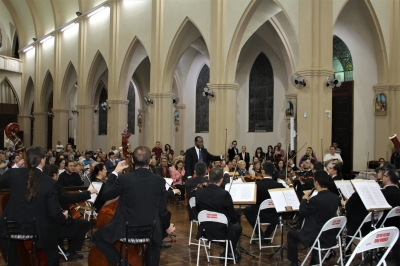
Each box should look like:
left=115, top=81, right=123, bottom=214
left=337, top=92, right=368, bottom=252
left=92, top=146, right=170, bottom=265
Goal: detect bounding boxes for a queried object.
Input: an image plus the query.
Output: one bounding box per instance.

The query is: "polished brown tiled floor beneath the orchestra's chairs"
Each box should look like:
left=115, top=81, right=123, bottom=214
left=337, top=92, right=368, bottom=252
left=0, top=202, right=395, bottom=266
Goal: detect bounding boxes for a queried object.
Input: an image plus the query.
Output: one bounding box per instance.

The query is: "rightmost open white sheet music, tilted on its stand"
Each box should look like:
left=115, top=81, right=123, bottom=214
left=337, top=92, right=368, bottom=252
left=351, top=179, right=392, bottom=210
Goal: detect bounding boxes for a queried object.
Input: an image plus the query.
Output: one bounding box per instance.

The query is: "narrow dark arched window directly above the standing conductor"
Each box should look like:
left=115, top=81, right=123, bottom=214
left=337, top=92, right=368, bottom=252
left=196, top=65, right=210, bottom=133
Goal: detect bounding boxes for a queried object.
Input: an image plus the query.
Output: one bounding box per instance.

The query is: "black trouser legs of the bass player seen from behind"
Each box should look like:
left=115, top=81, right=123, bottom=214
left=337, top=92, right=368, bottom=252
left=92, top=228, right=161, bottom=266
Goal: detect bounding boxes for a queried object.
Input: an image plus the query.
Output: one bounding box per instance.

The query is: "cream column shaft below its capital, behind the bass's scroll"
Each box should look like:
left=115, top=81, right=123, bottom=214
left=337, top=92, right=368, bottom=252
left=107, top=100, right=129, bottom=148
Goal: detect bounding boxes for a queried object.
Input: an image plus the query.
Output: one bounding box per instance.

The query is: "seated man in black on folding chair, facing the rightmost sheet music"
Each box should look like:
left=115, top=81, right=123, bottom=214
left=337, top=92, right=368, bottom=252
left=287, top=171, right=338, bottom=266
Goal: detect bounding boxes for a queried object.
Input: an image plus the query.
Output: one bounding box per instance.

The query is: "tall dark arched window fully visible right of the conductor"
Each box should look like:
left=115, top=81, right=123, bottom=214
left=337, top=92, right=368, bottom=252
left=249, top=53, right=274, bottom=132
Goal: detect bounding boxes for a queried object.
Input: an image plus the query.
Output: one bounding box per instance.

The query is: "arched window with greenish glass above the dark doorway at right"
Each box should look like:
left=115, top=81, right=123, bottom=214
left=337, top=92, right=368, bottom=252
left=332, top=35, right=353, bottom=82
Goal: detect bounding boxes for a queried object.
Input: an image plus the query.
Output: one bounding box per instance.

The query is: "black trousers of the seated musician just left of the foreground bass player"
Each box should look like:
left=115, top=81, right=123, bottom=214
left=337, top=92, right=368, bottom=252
left=57, top=219, right=90, bottom=253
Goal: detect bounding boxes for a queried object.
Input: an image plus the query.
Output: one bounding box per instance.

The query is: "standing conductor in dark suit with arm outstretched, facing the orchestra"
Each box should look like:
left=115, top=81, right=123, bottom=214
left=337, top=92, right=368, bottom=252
left=184, top=136, right=222, bottom=180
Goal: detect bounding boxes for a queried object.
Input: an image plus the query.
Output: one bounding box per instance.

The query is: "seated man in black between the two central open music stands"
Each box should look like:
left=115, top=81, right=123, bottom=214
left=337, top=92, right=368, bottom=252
left=244, top=162, right=284, bottom=238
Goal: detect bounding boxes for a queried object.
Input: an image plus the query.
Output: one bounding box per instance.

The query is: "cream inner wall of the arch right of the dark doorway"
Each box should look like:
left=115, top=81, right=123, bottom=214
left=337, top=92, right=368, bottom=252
left=333, top=18, right=378, bottom=169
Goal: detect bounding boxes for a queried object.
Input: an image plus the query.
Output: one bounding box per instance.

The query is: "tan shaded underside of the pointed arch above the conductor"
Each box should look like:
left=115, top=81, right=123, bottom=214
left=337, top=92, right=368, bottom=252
left=163, top=17, right=209, bottom=91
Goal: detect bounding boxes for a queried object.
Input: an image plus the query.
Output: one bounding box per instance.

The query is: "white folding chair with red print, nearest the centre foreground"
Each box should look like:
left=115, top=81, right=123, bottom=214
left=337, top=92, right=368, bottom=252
left=197, top=211, right=236, bottom=266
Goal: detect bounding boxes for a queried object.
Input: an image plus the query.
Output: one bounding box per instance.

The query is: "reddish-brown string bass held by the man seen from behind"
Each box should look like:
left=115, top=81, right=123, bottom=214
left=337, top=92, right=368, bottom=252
left=88, top=129, right=145, bottom=266
